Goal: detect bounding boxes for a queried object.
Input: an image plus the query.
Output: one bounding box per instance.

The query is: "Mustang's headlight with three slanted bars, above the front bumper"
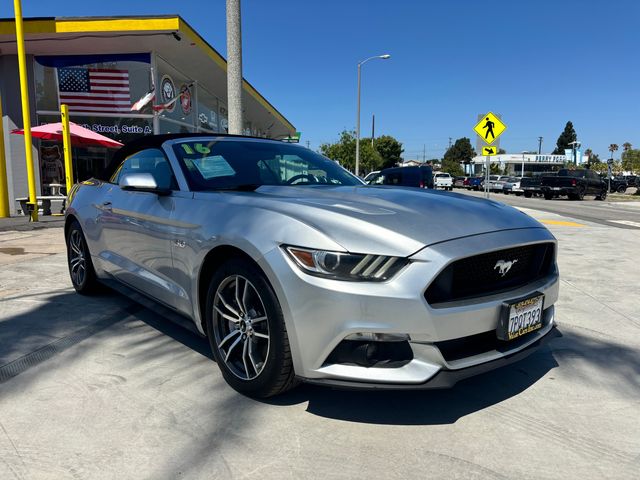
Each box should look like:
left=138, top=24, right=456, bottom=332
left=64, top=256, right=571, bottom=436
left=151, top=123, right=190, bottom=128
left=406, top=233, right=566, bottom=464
left=283, top=246, right=409, bottom=282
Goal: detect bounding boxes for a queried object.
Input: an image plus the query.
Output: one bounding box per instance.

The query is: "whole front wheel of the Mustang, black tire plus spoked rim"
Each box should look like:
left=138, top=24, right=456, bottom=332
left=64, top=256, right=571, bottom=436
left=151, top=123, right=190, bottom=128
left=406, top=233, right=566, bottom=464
left=205, top=257, right=297, bottom=398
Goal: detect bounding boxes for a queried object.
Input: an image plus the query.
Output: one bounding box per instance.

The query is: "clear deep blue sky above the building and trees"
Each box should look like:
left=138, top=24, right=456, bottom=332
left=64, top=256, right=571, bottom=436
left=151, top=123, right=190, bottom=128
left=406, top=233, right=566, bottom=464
left=12, top=0, right=640, bottom=159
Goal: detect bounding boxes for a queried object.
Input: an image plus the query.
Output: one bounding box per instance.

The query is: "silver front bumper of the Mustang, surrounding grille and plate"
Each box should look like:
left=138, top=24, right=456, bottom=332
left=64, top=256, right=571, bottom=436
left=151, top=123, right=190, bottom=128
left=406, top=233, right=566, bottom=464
left=261, top=228, right=558, bottom=388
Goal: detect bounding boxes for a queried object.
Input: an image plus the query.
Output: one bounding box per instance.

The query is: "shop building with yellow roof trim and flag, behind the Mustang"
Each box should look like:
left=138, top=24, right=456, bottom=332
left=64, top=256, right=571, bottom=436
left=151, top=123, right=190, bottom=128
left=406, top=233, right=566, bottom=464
left=0, top=15, right=296, bottom=213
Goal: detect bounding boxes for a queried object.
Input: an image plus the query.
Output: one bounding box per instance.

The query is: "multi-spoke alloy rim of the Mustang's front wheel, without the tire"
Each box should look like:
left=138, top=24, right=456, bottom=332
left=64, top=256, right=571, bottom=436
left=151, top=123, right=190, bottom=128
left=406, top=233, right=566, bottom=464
left=213, top=275, right=270, bottom=380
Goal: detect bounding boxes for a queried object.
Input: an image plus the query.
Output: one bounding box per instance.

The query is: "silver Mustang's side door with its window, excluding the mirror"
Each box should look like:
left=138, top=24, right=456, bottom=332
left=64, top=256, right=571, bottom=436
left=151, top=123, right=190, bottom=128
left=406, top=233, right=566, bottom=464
left=97, top=148, right=178, bottom=306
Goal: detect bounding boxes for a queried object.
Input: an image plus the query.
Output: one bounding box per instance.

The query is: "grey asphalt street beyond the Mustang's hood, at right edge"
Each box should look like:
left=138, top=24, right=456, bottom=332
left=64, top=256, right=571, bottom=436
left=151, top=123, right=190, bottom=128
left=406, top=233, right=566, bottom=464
left=455, top=189, right=640, bottom=229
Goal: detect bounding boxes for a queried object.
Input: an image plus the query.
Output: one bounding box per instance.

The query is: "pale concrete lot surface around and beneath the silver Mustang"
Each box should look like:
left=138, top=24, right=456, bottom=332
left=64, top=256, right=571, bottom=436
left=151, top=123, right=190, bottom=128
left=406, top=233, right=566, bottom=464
left=0, top=216, right=640, bottom=479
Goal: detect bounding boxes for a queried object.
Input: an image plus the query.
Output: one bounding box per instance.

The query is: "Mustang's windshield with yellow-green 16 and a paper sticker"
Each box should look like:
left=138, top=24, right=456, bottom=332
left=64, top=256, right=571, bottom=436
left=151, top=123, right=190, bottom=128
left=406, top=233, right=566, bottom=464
left=173, top=138, right=362, bottom=190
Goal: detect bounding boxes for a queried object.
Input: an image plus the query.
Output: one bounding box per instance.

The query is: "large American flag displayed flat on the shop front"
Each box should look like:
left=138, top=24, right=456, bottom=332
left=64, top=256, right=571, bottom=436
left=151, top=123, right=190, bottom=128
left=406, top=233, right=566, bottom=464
left=58, top=67, right=131, bottom=113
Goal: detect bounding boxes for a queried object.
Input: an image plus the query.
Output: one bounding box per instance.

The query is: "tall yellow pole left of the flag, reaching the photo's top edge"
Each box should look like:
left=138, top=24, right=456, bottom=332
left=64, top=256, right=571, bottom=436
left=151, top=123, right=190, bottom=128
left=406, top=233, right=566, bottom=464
left=13, top=0, right=38, bottom=222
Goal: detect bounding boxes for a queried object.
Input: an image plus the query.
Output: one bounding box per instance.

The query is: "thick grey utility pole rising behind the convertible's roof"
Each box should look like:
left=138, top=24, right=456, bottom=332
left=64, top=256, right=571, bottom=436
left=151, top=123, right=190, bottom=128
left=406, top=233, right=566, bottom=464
left=227, top=0, right=244, bottom=135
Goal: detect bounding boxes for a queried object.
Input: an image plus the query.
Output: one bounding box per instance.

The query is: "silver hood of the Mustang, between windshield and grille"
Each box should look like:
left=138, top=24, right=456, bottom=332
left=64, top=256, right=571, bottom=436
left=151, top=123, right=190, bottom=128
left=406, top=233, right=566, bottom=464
left=220, top=186, right=544, bottom=256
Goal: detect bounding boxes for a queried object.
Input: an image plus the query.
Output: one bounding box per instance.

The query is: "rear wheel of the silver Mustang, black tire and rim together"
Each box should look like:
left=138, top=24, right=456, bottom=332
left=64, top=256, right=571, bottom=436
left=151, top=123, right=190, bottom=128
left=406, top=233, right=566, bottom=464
left=65, top=220, right=100, bottom=295
